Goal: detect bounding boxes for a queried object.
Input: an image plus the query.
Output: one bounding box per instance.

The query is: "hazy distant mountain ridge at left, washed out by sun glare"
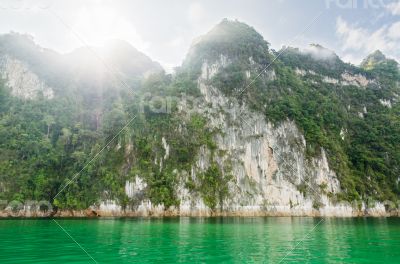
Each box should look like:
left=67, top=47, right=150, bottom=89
left=0, top=33, right=163, bottom=99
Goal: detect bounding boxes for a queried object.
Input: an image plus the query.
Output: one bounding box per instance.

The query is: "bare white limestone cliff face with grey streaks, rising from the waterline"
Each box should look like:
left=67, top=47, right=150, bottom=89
left=85, top=55, right=387, bottom=217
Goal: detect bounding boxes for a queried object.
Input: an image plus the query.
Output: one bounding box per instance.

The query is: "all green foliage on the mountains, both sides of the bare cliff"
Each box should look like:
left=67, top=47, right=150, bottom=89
left=0, top=20, right=400, bottom=210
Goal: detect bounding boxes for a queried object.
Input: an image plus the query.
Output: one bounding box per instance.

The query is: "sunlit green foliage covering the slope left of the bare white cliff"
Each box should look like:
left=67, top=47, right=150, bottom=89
left=0, top=61, right=219, bottom=209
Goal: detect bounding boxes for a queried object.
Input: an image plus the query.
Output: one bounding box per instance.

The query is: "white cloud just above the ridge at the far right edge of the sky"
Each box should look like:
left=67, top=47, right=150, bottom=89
left=336, top=17, right=400, bottom=62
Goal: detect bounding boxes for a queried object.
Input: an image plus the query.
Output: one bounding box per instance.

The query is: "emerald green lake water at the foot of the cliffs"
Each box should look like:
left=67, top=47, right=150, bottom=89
left=0, top=217, right=400, bottom=263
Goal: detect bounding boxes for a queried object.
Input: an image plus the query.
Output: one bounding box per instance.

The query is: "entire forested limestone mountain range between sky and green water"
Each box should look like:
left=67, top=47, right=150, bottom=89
left=0, top=19, right=400, bottom=216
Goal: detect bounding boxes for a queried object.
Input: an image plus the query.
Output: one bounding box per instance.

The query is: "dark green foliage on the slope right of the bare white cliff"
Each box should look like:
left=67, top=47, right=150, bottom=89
left=189, top=21, right=400, bottom=201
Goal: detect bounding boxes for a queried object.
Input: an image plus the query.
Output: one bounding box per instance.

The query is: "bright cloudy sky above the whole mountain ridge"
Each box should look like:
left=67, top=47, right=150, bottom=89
left=0, top=0, right=400, bottom=70
